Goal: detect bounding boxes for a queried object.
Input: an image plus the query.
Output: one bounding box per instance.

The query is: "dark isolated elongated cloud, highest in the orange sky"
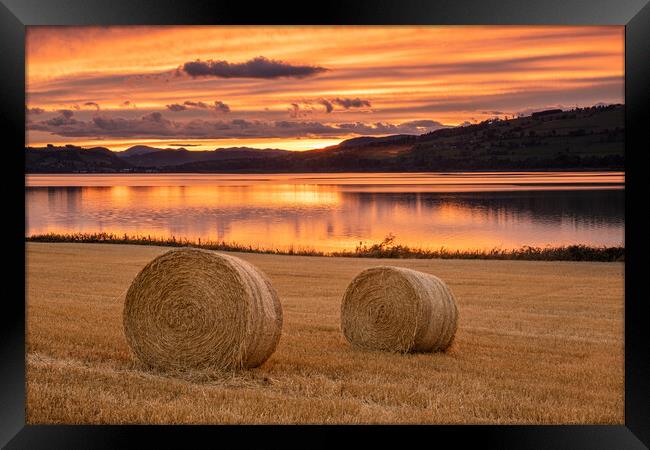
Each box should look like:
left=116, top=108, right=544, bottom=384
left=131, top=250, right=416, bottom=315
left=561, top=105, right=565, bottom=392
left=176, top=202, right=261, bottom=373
left=182, top=56, right=327, bottom=79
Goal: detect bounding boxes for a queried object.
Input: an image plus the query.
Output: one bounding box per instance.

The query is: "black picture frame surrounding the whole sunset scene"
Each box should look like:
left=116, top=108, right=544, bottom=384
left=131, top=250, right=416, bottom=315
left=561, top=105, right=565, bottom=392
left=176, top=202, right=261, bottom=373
left=0, top=0, right=650, bottom=449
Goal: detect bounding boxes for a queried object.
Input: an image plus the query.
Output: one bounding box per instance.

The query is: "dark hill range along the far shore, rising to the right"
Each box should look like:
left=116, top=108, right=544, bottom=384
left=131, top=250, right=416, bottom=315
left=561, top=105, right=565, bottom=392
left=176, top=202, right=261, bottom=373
left=26, top=105, right=625, bottom=173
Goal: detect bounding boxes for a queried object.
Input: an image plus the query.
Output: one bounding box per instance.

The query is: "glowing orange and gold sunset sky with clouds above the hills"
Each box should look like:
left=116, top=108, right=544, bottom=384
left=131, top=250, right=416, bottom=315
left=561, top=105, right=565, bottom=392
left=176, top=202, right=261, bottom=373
left=26, top=26, right=624, bottom=150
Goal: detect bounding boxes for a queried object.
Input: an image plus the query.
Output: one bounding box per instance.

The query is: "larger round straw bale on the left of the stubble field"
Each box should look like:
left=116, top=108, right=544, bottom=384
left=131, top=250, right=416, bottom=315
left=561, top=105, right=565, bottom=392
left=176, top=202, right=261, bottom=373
left=123, top=248, right=282, bottom=372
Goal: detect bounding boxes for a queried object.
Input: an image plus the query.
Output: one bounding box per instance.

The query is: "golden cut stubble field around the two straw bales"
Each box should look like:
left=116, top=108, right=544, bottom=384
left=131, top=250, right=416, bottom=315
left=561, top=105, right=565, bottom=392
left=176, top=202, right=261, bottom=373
left=26, top=243, right=624, bottom=424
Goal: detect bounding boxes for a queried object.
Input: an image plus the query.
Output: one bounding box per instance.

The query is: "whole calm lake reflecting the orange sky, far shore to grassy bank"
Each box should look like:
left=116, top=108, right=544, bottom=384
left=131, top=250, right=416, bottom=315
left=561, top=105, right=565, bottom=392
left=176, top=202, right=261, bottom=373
left=25, top=172, right=625, bottom=251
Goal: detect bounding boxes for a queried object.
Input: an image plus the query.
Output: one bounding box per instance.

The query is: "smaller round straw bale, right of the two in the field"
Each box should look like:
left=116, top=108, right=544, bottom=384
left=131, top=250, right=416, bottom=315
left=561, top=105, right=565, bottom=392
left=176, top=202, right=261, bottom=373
left=341, top=266, right=458, bottom=353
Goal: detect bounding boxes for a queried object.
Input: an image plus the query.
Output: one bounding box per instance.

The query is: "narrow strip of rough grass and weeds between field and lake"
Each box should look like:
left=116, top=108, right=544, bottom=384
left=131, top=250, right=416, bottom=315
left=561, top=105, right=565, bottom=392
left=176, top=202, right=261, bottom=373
left=26, top=233, right=625, bottom=262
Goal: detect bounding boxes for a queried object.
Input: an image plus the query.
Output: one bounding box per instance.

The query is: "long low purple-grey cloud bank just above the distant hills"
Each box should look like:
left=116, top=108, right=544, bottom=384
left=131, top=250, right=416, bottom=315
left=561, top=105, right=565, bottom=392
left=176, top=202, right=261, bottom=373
left=28, top=112, right=445, bottom=139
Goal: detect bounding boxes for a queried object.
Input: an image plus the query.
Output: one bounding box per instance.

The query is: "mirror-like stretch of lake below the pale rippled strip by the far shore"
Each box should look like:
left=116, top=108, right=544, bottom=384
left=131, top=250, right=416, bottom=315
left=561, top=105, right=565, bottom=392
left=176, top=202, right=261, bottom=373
left=25, top=180, right=624, bottom=250
